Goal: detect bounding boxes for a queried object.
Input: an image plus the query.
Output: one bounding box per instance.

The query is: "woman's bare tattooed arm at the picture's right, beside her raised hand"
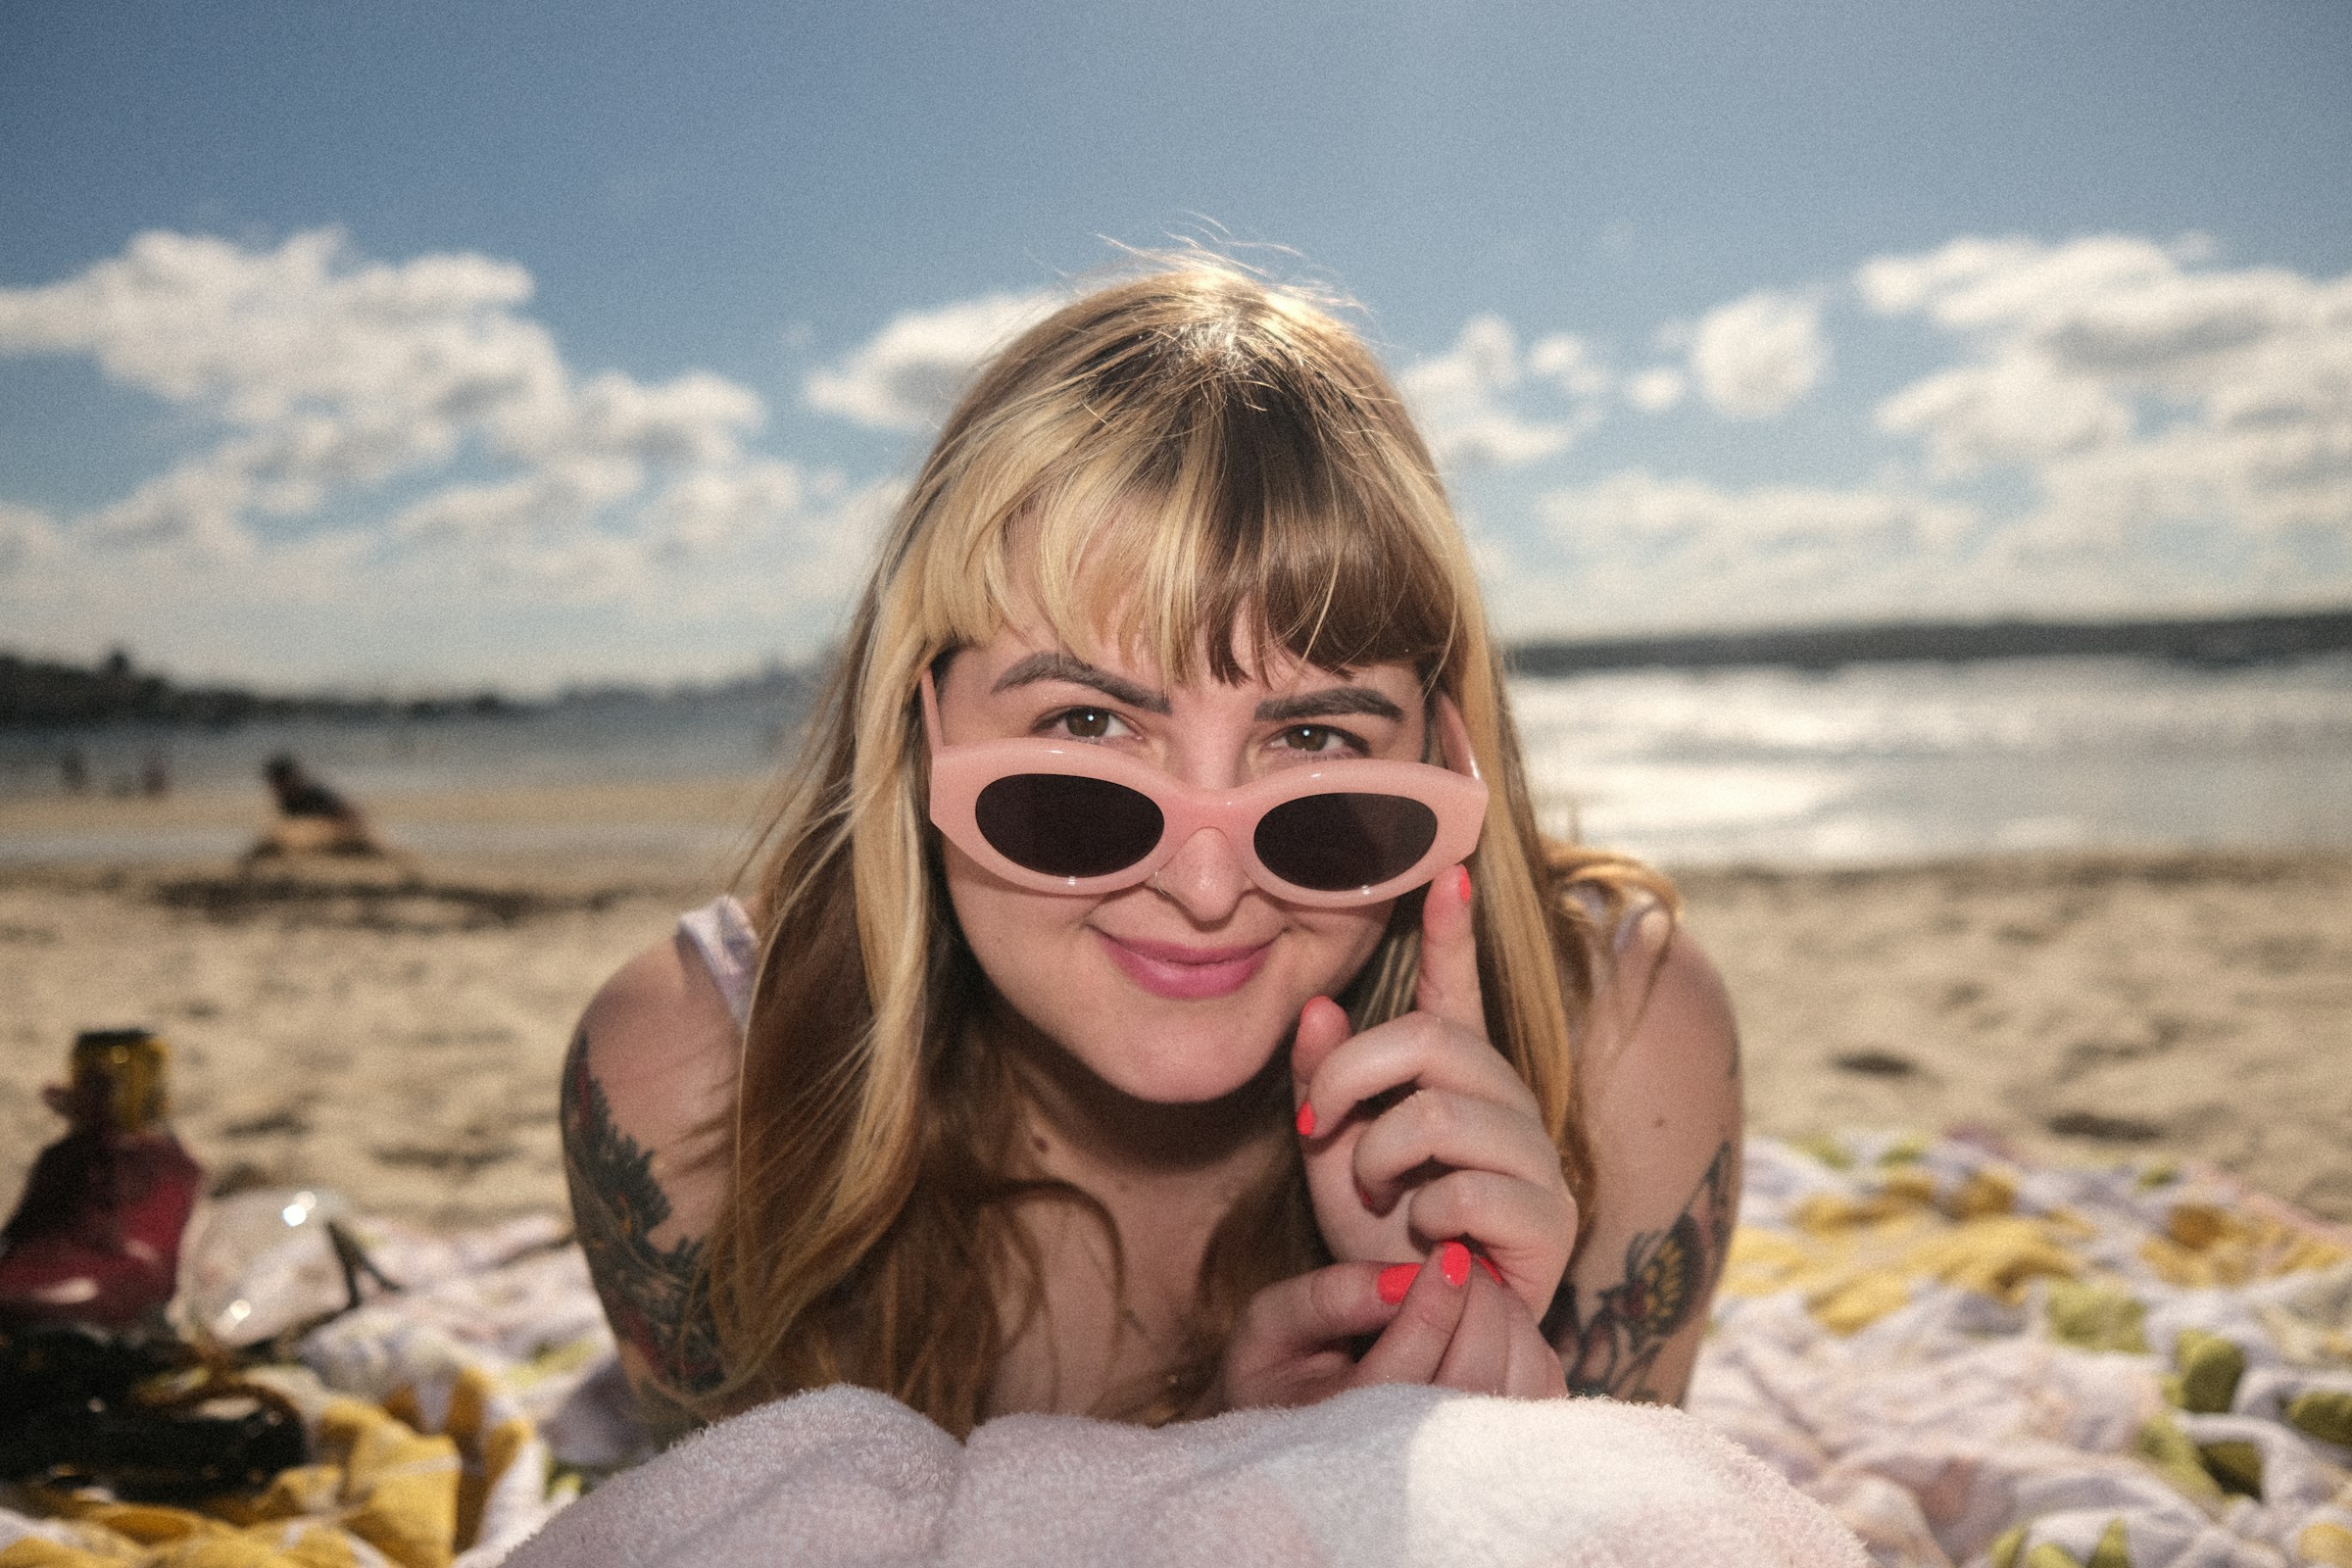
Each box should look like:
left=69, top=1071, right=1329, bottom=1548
left=1543, top=909, right=1740, bottom=1403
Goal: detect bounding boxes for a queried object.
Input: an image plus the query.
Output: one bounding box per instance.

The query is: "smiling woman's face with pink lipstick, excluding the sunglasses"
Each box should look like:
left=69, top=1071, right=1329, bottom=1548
left=939, top=623, right=1425, bottom=1104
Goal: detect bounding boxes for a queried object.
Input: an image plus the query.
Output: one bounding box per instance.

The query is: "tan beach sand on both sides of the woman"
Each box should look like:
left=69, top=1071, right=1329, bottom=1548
left=0, top=780, right=2352, bottom=1225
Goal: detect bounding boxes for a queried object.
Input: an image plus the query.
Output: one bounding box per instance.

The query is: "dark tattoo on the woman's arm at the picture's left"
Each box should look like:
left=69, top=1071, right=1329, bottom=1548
left=560, top=1030, right=722, bottom=1419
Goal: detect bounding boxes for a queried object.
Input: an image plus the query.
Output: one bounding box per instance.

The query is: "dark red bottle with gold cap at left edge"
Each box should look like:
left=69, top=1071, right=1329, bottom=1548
left=0, top=1030, right=205, bottom=1328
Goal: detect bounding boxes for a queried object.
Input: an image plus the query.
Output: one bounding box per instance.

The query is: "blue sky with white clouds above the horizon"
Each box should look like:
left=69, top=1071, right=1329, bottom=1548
left=0, top=0, right=2352, bottom=686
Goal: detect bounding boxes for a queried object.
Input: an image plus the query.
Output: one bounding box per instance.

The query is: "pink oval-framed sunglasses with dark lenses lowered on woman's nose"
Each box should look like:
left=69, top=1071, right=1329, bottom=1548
left=922, top=670, right=1487, bottom=909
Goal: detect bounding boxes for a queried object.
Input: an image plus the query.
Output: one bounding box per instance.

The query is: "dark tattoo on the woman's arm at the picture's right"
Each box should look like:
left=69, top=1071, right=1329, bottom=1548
left=1543, top=1143, right=1739, bottom=1403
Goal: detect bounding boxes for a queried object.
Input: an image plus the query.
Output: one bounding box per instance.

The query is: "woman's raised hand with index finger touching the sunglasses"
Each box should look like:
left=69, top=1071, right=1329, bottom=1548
left=1292, top=867, right=1578, bottom=1321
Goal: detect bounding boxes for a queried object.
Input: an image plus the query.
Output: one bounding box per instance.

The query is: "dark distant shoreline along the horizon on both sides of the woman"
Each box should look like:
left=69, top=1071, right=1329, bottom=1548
left=0, top=609, right=2352, bottom=729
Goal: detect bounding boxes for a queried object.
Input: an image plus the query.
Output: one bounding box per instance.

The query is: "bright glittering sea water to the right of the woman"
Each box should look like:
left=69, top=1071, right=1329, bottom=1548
left=1515, top=656, right=2352, bottom=865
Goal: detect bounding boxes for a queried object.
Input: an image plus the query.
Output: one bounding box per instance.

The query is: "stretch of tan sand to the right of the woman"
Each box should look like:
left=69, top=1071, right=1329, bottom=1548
left=1682, top=856, right=2352, bottom=1220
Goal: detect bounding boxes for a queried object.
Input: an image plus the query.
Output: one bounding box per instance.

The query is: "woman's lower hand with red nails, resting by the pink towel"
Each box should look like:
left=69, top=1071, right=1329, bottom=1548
left=1211, top=1242, right=1566, bottom=1410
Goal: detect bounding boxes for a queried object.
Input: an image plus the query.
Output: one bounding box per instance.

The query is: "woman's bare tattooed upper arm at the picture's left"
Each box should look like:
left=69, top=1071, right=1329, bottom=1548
left=560, top=936, right=741, bottom=1441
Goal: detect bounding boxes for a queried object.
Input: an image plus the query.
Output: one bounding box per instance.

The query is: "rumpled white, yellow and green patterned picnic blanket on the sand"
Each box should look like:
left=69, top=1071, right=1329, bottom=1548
left=0, top=1133, right=2352, bottom=1568
